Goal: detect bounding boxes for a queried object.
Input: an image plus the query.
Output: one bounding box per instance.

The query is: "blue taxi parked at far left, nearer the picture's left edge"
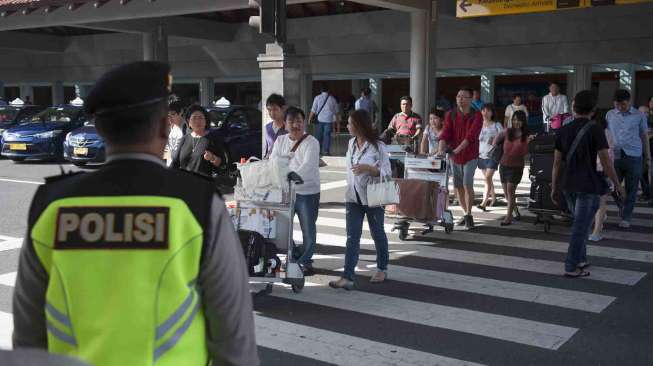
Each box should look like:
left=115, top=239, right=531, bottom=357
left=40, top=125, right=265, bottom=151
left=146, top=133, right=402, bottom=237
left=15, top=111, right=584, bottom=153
left=2, top=104, right=86, bottom=161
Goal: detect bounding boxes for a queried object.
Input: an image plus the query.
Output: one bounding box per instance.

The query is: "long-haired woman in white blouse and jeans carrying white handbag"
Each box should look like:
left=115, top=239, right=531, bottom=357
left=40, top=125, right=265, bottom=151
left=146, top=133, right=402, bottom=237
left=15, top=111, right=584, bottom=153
left=329, top=110, right=392, bottom=290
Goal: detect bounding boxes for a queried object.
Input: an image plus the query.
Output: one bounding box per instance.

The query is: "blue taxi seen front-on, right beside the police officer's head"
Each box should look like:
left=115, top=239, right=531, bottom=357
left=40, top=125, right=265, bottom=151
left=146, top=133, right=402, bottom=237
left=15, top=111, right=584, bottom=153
left=63, top=122, right=106, bottom=166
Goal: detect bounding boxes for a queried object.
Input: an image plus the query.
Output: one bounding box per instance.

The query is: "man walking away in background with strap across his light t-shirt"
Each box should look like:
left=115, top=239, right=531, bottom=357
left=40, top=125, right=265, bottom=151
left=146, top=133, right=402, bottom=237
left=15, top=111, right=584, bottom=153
left=308, top=85, right=340, bottom=155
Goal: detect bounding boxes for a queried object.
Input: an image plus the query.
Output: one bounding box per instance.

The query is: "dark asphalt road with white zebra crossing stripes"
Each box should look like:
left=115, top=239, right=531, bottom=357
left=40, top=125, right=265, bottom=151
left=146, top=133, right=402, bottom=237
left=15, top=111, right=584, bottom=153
left=0, top=160, right=653, bottom=366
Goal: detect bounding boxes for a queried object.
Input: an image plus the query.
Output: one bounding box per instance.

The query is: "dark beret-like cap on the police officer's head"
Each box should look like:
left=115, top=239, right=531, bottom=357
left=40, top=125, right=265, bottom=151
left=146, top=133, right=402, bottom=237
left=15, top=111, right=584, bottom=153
left=85, top=61, right=172, bottom=114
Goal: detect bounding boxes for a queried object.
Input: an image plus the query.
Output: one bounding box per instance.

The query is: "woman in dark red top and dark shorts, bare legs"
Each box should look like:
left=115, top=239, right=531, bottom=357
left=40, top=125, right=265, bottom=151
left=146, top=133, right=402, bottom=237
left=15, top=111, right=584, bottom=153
left=497, top=111, right=533, bottom=226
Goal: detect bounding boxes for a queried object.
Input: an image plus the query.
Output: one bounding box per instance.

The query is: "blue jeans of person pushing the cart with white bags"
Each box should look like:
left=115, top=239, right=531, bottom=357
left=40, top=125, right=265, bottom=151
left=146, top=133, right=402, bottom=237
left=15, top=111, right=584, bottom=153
left=289, top=193, right=320, bottom=264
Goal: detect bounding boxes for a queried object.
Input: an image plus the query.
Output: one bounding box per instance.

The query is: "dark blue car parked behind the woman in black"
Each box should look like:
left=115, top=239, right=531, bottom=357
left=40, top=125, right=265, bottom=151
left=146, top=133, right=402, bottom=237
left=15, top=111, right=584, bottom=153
left=207, top=105, right=263, bottom=170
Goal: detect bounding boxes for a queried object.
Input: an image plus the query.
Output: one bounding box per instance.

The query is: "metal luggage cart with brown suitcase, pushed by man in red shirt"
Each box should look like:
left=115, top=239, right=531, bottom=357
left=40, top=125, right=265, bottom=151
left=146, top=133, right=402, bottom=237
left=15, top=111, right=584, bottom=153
left=392, top=153, right=453, bottom=240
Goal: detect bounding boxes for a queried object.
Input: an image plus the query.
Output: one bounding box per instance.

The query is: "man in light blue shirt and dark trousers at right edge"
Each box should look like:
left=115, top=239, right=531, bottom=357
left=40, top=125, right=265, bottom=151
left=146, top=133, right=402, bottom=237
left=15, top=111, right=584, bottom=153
left=605, top=89, right=651, bottom=229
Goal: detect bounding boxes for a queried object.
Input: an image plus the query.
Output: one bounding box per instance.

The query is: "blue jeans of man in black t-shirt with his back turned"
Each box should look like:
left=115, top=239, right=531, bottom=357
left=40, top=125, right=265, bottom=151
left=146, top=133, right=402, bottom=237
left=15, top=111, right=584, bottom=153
left=565, top=192, right=601, bottom=272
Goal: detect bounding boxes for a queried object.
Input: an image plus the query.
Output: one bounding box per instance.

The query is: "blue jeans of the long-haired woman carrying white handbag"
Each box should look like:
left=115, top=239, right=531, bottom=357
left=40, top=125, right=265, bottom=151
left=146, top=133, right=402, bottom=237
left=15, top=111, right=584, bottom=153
left=343, top=202, right=389, bottom=281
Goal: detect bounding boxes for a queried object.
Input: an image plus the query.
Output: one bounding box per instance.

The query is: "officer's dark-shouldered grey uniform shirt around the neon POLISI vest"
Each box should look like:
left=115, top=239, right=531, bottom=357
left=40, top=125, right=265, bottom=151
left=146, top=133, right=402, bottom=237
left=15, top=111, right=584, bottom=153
left=13, top=154, right=258, bottom=365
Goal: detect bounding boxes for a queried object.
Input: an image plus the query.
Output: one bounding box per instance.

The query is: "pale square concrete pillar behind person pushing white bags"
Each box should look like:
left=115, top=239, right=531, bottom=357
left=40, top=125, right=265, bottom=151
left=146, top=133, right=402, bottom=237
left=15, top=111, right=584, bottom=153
left=257, top=43, right=305, bottom=153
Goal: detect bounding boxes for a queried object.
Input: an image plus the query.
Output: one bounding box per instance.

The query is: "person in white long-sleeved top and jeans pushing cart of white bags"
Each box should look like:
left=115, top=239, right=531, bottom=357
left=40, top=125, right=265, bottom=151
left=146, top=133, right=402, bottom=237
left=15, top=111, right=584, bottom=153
left=270, top=107, right=320, bottom=276
